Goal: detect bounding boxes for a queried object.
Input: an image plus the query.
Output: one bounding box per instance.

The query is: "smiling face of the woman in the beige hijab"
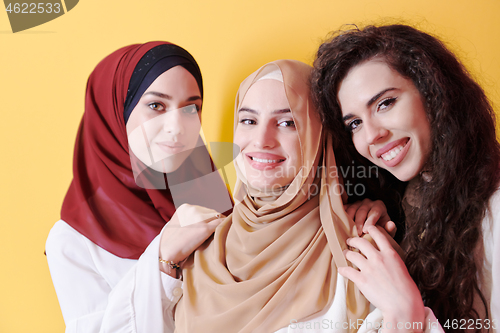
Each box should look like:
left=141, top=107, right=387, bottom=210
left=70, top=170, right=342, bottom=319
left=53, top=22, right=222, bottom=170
left=234, top=79, right=301, bottom=191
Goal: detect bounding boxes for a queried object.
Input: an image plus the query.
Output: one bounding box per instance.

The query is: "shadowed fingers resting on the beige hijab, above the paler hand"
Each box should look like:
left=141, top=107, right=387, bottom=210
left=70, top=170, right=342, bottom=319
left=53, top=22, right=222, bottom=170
left=344, top=199, right=396, bottom=237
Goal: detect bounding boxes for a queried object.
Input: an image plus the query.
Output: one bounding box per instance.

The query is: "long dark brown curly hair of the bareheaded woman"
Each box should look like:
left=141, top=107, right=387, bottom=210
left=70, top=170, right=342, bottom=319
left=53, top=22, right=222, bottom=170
left=311, top=25, right=500, bottom=323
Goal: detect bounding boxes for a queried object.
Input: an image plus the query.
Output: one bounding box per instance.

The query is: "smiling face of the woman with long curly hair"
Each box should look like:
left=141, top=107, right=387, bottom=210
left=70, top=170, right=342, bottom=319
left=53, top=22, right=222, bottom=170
left=337, top=59, right=431, bottom=181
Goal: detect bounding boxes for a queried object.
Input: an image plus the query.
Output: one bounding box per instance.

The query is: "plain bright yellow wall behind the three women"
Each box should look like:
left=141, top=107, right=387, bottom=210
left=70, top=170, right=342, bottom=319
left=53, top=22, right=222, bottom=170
left=0, top=0, right=500, bottom=333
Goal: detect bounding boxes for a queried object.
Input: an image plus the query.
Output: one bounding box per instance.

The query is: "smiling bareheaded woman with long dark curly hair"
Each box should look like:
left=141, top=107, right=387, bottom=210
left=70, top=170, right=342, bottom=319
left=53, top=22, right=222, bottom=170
left=312, top=25, right=500, bottom=331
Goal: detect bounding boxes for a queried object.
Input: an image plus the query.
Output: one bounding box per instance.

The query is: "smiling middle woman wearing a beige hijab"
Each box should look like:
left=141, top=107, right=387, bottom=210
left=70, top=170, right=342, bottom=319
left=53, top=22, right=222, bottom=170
left=175, top=60, right=368, bottom=332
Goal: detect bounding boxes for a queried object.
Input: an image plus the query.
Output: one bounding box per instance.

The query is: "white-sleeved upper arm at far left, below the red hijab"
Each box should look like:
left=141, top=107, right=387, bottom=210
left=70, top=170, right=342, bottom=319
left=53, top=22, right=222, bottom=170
left=45, top=220, right=137, bottom=333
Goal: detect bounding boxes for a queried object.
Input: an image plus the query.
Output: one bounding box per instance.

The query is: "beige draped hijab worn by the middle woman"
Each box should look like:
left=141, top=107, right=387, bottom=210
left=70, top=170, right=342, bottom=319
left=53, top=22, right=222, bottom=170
left=175, top=60, right=369, bottom=333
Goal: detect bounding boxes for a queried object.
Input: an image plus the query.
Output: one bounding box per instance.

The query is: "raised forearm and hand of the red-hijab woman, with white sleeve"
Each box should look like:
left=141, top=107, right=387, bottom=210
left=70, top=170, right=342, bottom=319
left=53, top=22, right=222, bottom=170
left=100, top=205, right=222, bottom=333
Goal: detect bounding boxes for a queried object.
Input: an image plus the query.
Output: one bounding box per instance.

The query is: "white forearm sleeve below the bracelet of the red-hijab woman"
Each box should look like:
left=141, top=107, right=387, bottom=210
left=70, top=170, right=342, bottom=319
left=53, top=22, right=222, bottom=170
left=100, top=227, right=182, bottom=333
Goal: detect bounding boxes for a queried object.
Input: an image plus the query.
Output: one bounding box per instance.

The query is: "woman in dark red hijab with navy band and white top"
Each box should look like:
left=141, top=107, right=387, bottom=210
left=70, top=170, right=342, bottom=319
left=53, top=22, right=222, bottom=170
left=46, top=42, right=232, bottom=332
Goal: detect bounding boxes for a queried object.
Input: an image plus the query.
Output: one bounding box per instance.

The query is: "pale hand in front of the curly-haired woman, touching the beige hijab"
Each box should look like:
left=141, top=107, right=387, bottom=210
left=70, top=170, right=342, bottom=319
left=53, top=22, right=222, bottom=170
left=338, top=226, right=425, bottom=331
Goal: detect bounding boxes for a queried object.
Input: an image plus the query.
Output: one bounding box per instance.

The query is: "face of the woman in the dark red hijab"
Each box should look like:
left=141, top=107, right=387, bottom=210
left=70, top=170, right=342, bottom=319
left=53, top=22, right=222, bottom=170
left=126, top=66, right=202, bottom=173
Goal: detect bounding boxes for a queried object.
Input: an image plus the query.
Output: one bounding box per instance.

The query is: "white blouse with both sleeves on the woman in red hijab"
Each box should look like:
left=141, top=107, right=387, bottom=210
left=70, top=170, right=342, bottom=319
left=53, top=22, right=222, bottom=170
left=46, top=220, right=182, bottom=333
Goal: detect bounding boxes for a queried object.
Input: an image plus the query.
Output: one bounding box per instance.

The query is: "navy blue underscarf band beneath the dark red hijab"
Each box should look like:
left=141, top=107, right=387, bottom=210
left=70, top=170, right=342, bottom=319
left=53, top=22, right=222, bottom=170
left=123, top=44, right=203, bottom=124
